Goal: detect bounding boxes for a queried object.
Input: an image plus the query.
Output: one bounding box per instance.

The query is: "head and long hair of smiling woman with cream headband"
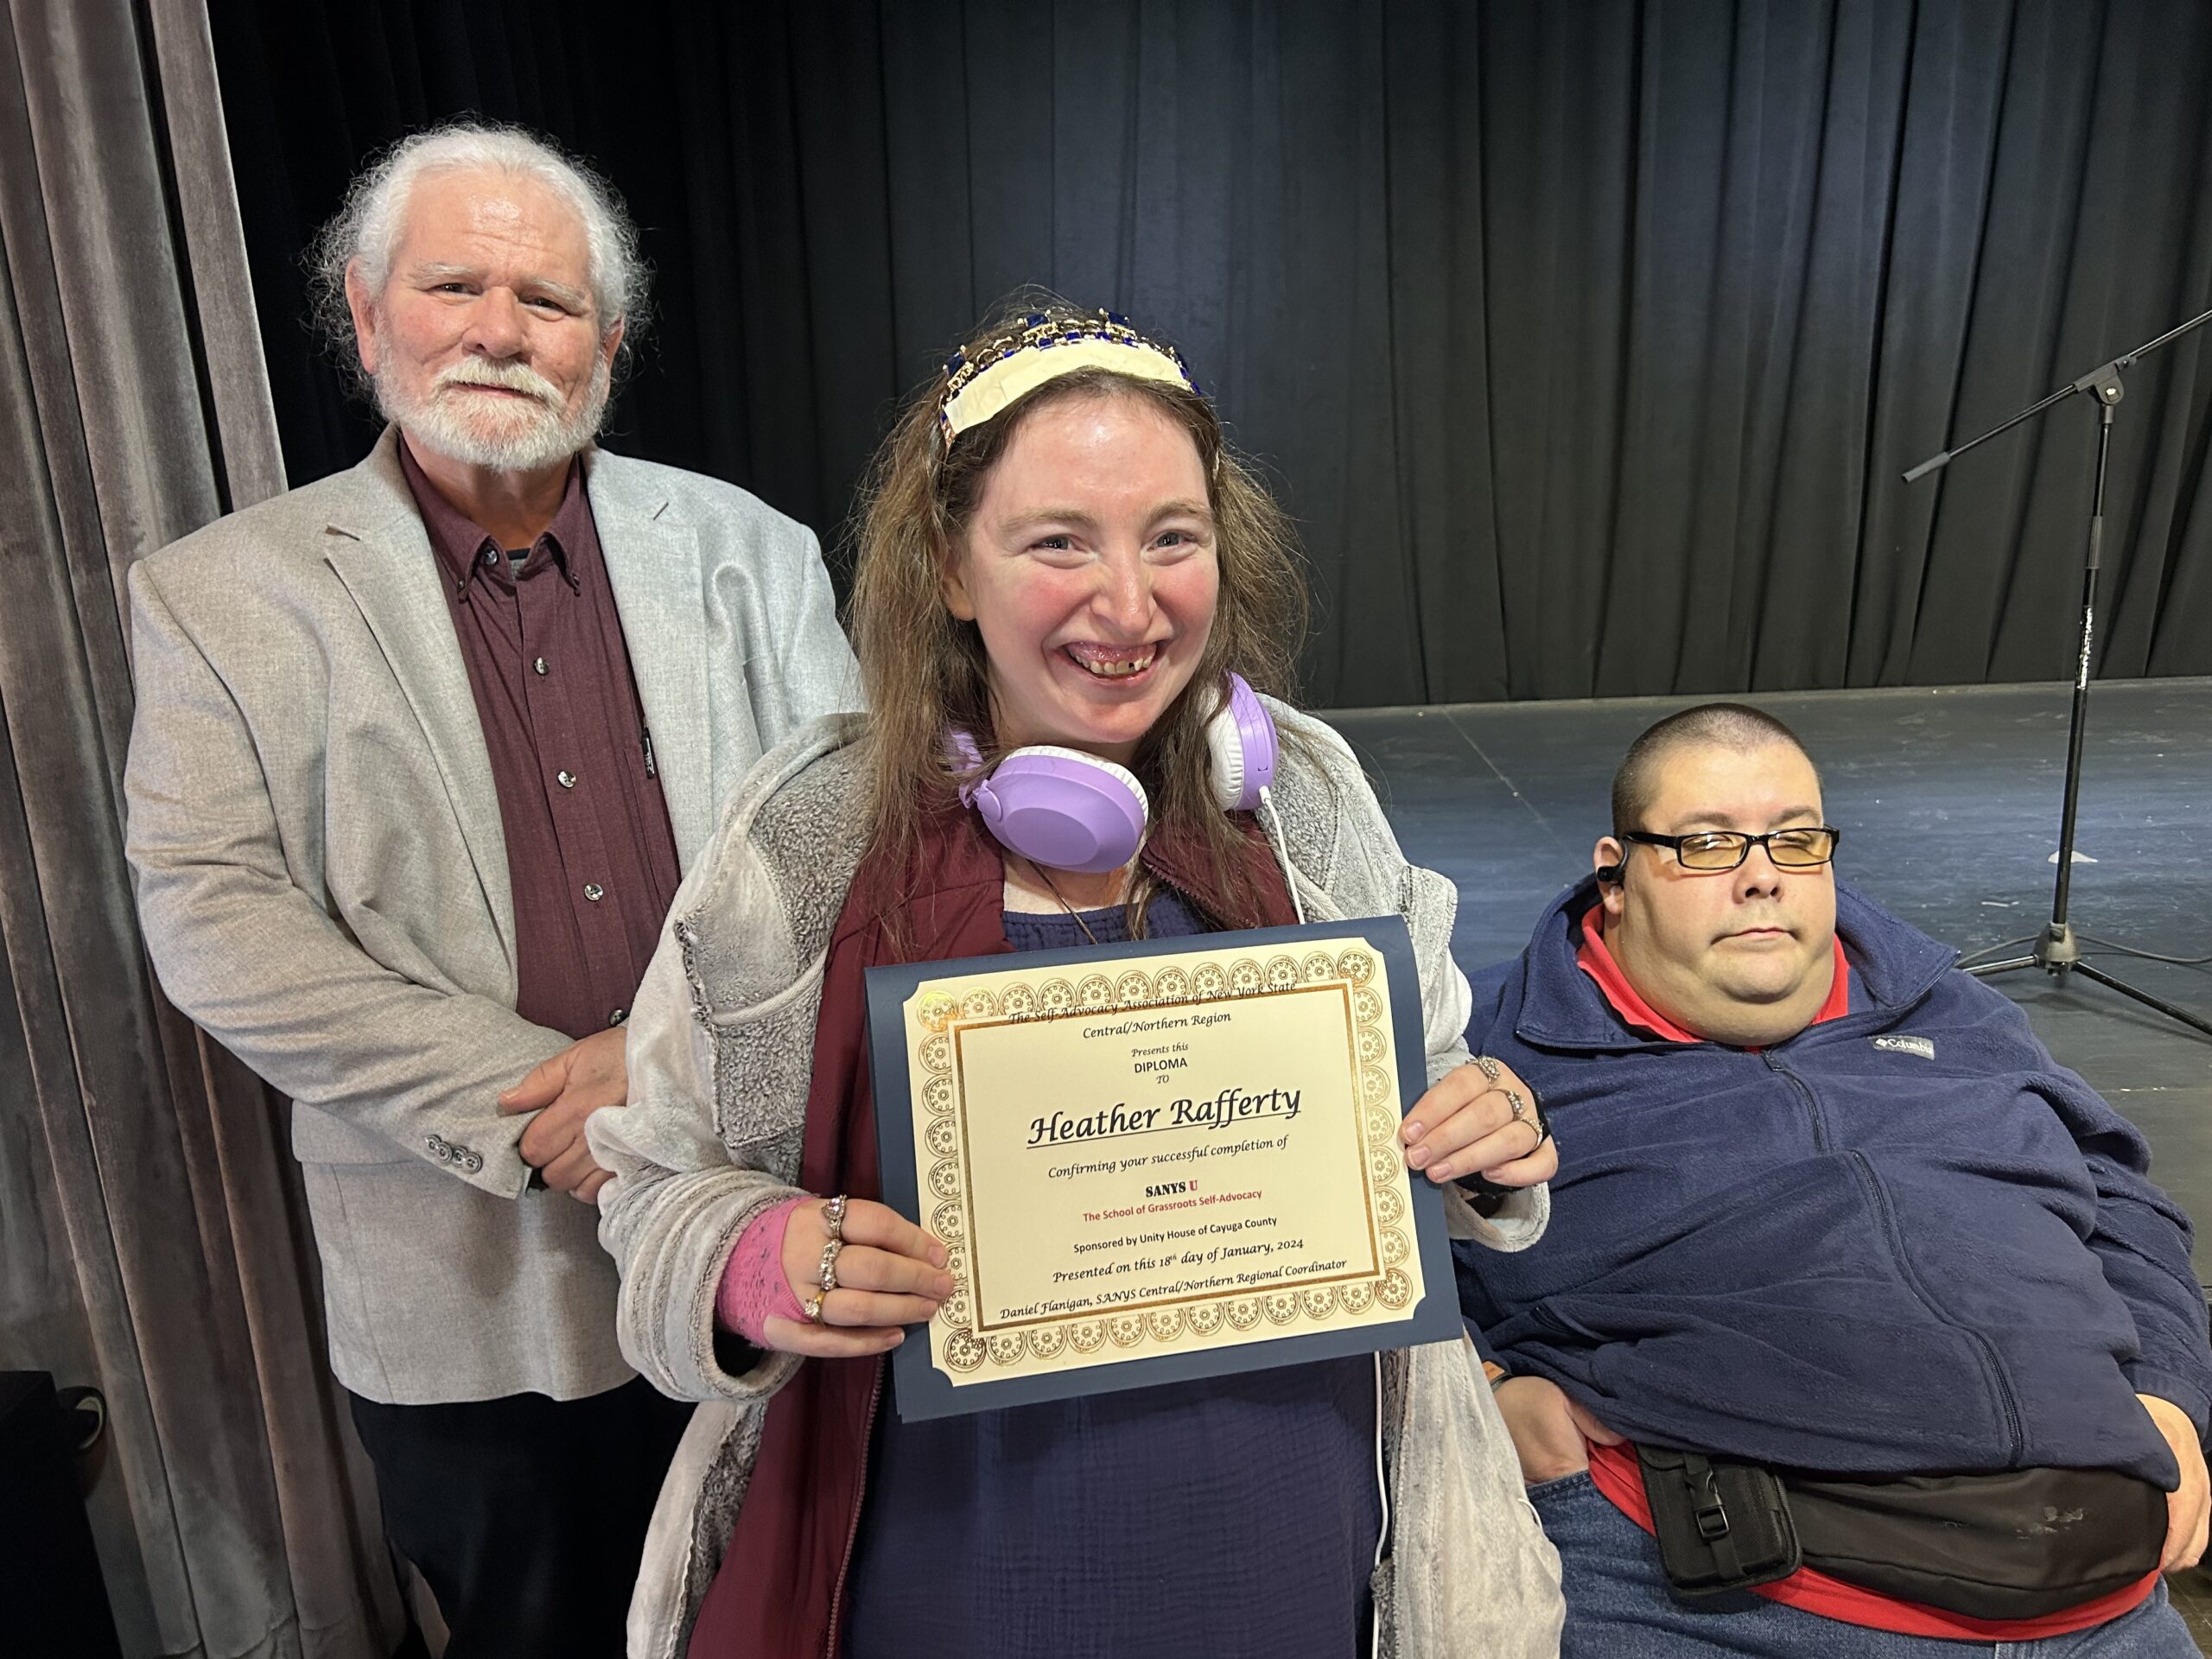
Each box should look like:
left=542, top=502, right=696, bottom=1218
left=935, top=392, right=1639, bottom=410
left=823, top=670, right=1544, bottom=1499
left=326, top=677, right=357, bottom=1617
left=852, top=299, right=1307, bottom=925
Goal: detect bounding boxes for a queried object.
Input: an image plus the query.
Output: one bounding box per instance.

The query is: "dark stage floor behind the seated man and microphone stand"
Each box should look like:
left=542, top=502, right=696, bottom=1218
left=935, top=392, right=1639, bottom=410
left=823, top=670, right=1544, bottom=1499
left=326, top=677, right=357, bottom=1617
left=1327, top=679, right=2212, bottom=1283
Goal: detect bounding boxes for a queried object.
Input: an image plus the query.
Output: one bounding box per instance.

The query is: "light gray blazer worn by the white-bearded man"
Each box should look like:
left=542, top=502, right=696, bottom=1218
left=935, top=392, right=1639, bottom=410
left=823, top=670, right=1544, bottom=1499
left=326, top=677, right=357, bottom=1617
left=124, top=429, right=858, bottom=1405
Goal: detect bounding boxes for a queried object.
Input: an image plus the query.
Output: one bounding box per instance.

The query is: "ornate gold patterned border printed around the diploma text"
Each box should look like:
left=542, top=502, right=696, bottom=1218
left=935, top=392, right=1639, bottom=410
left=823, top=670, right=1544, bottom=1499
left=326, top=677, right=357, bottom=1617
left=907, top=944, right=1418, bottom=1382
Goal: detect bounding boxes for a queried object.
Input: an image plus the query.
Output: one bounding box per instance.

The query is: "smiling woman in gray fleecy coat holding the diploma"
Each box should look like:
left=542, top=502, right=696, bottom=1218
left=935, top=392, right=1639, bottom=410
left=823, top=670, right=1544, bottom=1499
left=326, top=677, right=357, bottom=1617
left=591, top=301, right=1560, bottom=1659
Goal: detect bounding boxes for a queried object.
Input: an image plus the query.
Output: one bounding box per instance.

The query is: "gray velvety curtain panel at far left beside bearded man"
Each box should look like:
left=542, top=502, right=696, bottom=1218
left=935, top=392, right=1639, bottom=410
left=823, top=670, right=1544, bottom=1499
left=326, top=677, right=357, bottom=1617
left=0, top=0, right=403, bottom=1659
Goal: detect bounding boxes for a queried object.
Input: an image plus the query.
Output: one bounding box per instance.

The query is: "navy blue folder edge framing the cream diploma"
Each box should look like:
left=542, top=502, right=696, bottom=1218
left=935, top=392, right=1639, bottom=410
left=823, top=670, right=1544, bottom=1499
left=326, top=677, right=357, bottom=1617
left=868, top=916, right=1462, bottom=1422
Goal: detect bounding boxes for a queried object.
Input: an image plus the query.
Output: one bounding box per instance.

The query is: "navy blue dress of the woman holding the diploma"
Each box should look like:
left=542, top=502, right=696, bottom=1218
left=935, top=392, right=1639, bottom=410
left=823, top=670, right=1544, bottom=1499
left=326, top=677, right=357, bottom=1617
left=845, top=892, right=1382, bottom=1659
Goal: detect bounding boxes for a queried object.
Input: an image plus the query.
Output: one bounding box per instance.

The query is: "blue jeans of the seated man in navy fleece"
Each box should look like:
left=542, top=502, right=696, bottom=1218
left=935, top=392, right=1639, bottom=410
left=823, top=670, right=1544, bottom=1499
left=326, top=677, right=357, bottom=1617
left=1529, top=1473, right=2196, bottom=1659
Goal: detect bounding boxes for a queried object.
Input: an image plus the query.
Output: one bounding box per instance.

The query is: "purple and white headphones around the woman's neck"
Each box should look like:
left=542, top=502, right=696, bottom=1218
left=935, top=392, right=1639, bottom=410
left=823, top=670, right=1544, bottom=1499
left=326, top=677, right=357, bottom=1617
left=951, top=675, right=1276, bottom=874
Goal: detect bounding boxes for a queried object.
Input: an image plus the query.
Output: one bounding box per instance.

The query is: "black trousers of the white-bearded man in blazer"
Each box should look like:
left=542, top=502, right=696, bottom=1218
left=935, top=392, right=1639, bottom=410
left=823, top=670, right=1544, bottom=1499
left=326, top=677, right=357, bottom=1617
left=352, top=1378, right=690, bottom=1659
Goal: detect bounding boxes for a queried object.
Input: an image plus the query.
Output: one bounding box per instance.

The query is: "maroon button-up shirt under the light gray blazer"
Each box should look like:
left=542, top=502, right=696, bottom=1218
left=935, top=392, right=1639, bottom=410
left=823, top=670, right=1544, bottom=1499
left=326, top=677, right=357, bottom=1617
left=400, top=440, right=681, bottom=1038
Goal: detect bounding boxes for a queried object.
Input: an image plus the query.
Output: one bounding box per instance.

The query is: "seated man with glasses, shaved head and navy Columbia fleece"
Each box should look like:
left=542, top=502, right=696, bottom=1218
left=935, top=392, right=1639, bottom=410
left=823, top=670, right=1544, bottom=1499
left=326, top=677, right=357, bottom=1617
left=1460, top=703, right=2212, bottom=1659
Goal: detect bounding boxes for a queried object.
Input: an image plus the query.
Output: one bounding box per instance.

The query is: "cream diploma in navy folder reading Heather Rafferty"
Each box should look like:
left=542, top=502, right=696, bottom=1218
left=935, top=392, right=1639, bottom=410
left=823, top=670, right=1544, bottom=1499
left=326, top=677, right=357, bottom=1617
left=868, top=916, right=1460, bottom=1421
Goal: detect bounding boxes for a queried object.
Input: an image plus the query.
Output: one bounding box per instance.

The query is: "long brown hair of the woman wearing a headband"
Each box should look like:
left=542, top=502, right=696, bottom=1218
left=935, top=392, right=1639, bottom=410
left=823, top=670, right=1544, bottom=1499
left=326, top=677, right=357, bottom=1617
left=849, top=296, right=1307, bottom=927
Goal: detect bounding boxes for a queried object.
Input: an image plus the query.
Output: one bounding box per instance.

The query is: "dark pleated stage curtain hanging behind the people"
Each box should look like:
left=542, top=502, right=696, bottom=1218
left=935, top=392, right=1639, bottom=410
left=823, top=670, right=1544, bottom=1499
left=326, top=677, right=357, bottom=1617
left=213, top=0, right=2212, bottom=706
